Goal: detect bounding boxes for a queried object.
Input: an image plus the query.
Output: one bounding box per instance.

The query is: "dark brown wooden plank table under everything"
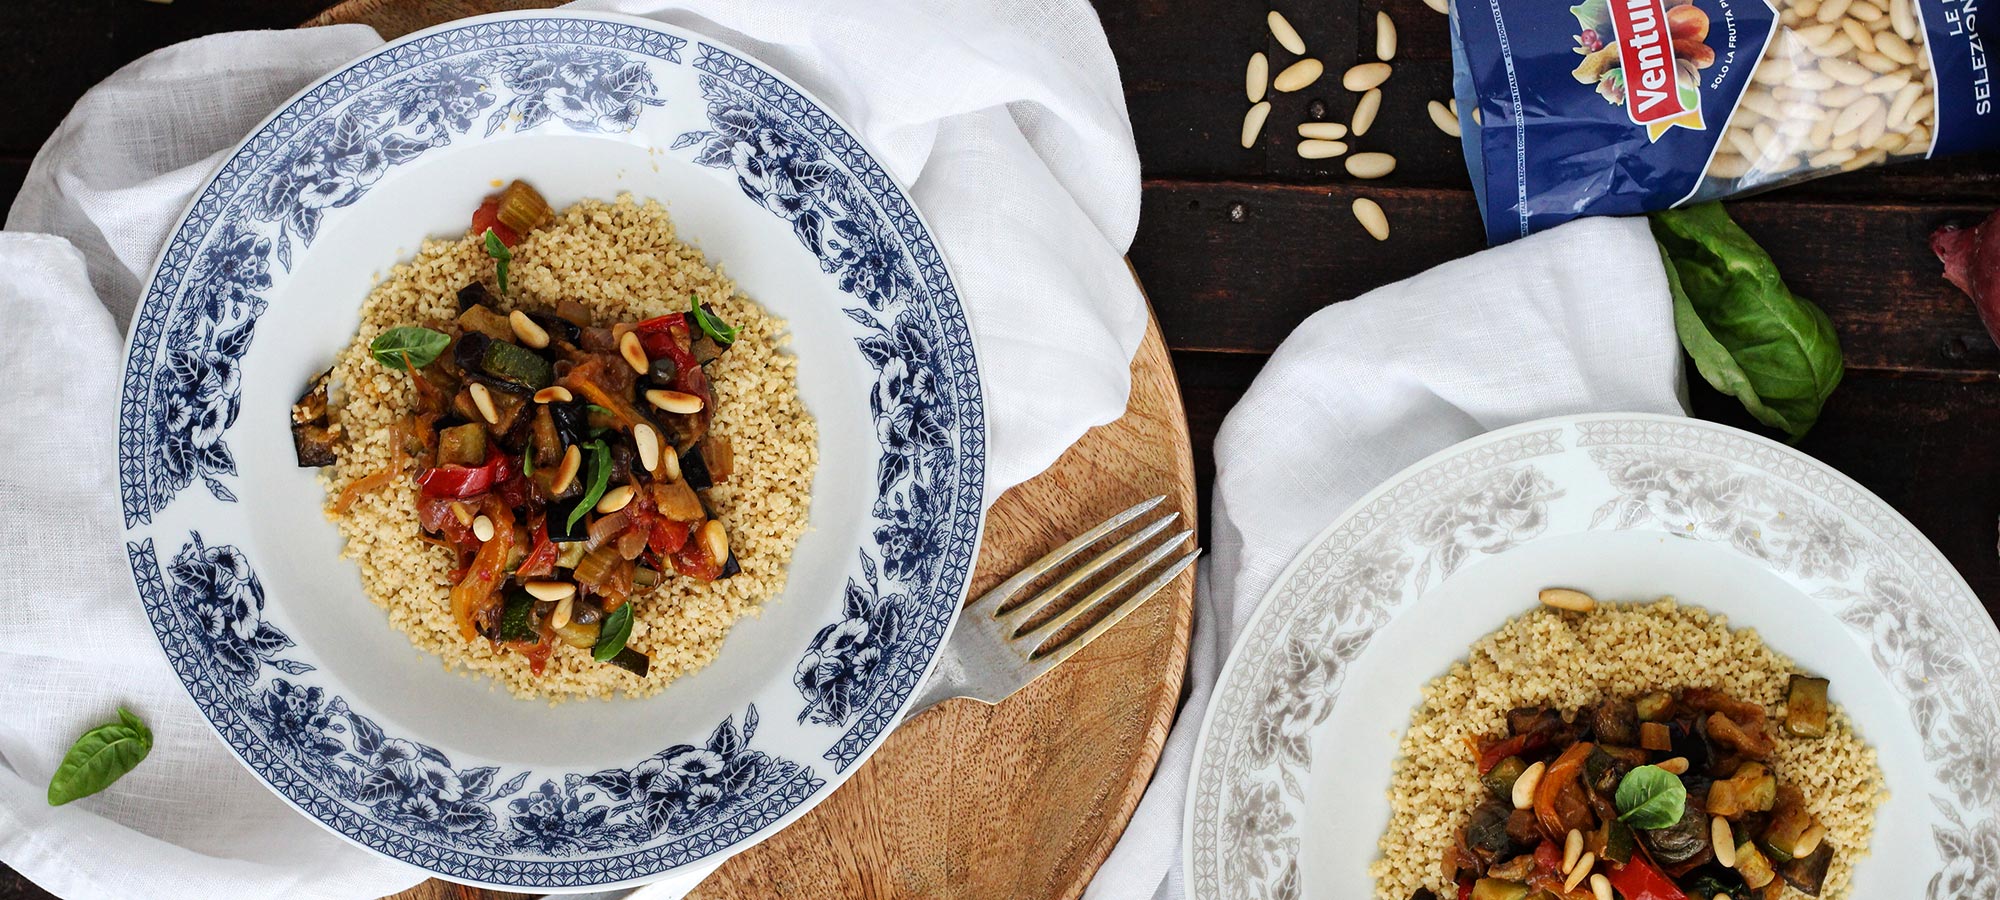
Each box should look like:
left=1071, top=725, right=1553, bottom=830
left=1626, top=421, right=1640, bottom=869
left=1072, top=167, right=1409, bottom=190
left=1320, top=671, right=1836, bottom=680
left=0, top=0, right=2000, bottom=900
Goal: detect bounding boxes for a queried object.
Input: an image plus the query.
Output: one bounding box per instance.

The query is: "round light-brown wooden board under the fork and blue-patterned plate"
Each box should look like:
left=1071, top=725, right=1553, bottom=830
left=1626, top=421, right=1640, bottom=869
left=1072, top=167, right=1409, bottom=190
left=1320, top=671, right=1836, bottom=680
left=306, top=0, right=1194, bottom=900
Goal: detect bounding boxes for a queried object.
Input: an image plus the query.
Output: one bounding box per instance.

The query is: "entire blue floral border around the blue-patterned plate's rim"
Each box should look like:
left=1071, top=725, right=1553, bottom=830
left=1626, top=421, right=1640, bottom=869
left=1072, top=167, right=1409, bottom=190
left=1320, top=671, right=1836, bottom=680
left=120, top=14, right=984, bottom=888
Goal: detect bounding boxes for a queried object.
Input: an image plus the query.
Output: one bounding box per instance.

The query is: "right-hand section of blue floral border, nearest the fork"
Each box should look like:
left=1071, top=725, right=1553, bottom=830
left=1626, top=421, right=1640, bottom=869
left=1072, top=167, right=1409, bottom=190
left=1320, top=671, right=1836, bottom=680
left=672, top=44, right=984, bottom=772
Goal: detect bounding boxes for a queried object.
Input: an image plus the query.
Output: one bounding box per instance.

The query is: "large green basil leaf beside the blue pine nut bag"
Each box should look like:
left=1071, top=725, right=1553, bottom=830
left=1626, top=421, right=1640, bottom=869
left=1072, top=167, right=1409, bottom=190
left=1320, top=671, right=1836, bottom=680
left=1652, top=202, right=1844, bottom=440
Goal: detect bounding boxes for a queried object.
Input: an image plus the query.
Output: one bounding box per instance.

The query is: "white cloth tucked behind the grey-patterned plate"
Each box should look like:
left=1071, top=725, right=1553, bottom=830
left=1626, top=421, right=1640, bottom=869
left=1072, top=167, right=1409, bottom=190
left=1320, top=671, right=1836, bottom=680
left=1084, top=218, right=1686, bottom=900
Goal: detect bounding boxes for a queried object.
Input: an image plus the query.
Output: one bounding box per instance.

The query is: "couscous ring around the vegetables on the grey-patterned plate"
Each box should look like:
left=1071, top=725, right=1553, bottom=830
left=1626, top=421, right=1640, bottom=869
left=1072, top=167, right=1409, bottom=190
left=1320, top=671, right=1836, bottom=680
left=1370, top=598, right=1888, bottom=900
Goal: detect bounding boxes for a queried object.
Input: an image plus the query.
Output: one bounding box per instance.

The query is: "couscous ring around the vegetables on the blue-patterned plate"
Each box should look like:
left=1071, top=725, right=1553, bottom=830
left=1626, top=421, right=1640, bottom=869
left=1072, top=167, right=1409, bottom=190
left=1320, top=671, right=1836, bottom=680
left=320, top=196, right=818, bottom=702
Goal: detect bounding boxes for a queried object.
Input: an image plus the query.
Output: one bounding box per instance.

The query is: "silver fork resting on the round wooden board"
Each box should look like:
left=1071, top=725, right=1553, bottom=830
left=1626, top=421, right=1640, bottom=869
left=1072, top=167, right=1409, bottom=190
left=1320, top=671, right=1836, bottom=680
left=908, top=496, right=1202, bottom=716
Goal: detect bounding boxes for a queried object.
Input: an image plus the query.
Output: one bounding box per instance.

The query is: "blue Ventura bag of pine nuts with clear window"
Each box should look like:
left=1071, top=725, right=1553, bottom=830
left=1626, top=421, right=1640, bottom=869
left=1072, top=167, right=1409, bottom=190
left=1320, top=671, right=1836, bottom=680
left=1452, top=0, right=2000, bottom=244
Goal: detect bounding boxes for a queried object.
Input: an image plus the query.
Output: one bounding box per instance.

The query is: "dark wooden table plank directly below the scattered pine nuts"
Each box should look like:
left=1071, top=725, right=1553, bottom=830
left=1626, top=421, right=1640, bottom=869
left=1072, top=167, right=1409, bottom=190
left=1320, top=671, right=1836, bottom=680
left=1132, top=180, right=2000, bottom=380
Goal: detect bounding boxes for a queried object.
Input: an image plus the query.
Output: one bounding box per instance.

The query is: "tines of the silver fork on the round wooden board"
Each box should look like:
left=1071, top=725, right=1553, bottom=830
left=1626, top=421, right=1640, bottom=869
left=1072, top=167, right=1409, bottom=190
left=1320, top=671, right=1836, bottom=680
left=974, top=496, right=1200, bottom=668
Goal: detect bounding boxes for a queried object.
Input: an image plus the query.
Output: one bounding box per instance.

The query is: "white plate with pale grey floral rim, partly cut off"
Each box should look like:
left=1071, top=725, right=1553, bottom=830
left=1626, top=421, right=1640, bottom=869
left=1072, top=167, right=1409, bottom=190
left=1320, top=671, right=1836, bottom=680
left=1184, top=414, right=2000, bottom=900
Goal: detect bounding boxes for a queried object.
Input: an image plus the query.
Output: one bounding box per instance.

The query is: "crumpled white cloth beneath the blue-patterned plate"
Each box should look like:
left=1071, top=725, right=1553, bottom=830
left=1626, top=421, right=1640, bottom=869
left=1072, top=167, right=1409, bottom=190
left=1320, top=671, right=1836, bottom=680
left=0, top=0, right=1146, bottom=900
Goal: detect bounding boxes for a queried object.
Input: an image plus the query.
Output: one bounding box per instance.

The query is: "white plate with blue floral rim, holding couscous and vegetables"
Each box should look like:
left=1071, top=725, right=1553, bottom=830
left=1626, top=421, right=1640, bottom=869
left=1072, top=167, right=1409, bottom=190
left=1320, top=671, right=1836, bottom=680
left=118, top=12, right=986, bottom=890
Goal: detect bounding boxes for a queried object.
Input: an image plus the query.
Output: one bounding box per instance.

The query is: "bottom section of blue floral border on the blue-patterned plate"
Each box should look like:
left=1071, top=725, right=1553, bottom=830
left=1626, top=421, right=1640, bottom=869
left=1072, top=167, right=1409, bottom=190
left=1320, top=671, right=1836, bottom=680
left=126, top=532, right=826, bottom=886
